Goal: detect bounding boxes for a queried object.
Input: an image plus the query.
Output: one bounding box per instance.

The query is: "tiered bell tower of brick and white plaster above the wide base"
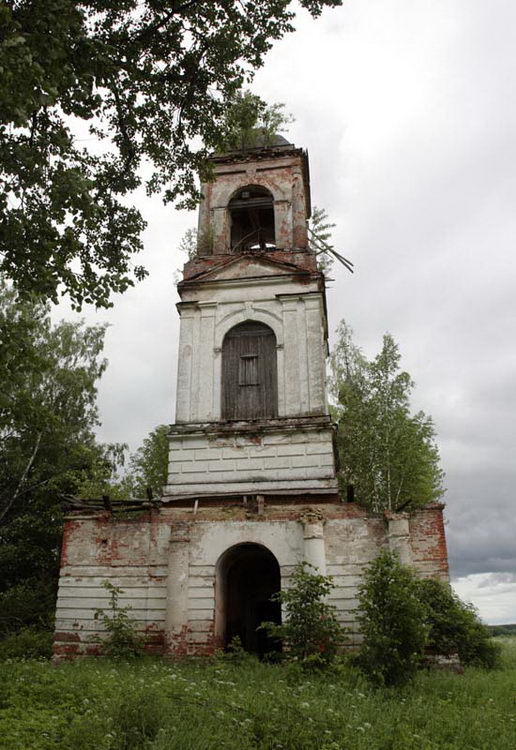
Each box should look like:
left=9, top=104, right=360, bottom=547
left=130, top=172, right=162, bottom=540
left=163, top=138, right=338, bottom=504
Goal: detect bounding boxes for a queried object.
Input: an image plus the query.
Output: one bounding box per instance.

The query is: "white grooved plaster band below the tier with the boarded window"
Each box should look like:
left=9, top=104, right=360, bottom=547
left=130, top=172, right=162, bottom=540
left=165, top=428, right=337, bottom=495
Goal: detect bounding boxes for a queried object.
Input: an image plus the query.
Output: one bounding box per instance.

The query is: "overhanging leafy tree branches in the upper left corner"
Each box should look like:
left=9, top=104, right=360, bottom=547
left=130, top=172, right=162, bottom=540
left=0, top=0, right=342, bottom=308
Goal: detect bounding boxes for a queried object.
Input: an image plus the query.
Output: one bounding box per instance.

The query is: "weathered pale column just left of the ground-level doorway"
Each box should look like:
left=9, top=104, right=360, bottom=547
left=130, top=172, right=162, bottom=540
left=166, top=523, right=190, bottom=648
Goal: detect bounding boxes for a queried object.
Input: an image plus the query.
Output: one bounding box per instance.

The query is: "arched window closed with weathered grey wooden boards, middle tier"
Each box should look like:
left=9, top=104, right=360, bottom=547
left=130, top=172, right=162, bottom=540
left=222, top=321, right=278, bottom=419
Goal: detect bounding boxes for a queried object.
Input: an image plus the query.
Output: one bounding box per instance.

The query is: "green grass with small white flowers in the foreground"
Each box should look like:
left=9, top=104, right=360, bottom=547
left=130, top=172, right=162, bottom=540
left=0, top=638, right=516, bottom=750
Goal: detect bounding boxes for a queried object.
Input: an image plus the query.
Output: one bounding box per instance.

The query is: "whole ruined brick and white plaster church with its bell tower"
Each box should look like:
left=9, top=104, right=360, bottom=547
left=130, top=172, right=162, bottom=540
left=54, top=138, right=448, bottom=659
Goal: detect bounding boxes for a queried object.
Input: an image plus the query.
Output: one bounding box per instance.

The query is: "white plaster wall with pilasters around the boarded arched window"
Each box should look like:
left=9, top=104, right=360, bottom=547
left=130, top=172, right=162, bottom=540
left=176, top=282, right=327, bottom=423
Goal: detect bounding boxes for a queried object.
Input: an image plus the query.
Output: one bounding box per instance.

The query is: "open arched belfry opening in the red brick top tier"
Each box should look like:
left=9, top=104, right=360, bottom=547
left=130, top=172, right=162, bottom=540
left=229, top=186, right=276, bottom=253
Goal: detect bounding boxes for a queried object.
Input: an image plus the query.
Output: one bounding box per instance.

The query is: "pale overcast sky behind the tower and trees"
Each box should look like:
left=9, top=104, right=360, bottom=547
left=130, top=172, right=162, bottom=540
left=54, top=0, right=516, bottom=623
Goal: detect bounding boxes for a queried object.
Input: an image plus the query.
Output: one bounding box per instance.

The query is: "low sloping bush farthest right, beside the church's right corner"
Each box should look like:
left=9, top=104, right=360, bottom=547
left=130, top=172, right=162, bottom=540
left=417, top=579, right=501, bottom=669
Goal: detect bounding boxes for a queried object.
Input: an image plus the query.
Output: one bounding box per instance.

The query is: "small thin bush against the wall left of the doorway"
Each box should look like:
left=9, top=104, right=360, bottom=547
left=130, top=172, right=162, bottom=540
left=95, top=581, right=145, bottom=659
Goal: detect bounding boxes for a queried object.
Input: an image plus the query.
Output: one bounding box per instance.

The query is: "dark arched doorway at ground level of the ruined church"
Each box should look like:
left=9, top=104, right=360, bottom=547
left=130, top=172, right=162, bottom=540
left=216, top=543, right=281, bottom=656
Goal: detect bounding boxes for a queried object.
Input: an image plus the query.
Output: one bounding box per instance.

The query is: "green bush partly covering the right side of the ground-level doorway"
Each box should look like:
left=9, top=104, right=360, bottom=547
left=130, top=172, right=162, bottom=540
left=262, top=562, right=344, bottom=669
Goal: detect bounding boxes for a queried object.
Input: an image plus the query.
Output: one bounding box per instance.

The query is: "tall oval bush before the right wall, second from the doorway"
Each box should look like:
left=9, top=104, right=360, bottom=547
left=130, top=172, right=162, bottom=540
left=357, top=550, right=427, bottom=685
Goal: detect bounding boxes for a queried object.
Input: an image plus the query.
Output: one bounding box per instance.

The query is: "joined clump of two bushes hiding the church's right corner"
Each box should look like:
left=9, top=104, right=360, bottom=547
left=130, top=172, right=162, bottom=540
left=357, top=550, right=500, bottom=686
